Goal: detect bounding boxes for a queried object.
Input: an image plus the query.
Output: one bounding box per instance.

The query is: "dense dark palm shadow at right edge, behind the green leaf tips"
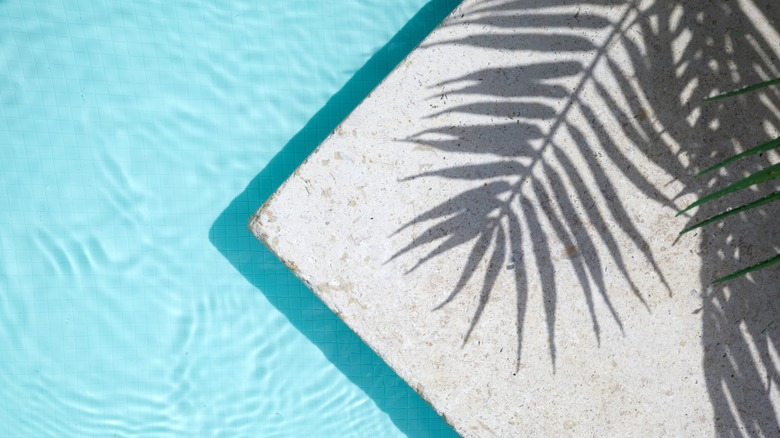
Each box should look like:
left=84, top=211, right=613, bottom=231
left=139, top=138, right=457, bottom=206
left=634, top=5, right=780, bottom=436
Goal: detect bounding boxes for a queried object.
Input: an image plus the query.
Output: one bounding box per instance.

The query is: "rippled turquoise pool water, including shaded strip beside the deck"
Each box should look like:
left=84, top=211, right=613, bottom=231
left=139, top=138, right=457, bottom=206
left=0, top=0, right=457, bottom=437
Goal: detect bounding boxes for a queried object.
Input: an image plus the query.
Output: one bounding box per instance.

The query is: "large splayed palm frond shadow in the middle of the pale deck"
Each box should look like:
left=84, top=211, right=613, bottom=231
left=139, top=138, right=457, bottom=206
left=393, top=0, right=673, bottom=367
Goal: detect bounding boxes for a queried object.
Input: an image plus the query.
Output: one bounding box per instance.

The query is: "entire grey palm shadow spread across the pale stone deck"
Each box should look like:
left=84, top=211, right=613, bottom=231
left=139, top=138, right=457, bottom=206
left=393, top=0, right=780, bottom=435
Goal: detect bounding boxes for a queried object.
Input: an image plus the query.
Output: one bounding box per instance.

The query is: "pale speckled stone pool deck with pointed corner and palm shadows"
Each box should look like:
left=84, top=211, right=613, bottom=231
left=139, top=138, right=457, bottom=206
left=250, top=0, right=780, bottom=436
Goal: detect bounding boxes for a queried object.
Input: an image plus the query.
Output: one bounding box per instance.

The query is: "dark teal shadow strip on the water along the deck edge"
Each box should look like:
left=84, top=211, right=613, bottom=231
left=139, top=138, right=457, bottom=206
left=209, top=0, right=459, bottom=436
